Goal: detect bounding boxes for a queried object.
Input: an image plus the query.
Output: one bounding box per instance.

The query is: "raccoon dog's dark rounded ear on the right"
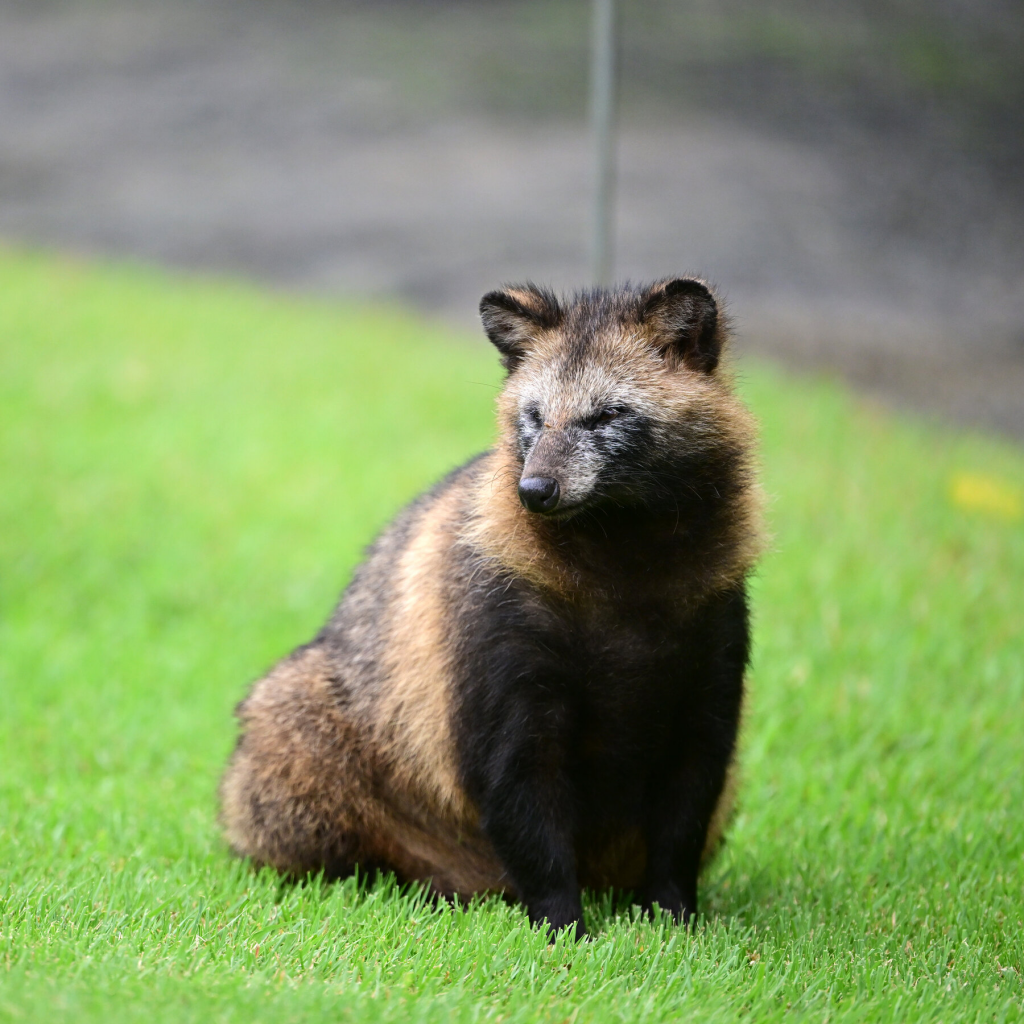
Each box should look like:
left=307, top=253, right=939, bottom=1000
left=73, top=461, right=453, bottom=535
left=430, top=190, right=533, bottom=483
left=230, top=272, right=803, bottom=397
left=640, top=278, right=725, bottom=374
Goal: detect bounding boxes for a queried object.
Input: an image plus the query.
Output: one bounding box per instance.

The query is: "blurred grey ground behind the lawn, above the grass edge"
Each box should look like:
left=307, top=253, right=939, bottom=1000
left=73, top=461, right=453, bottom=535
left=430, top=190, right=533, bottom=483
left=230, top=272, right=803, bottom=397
left=0, top=0, right=1024, bottom=436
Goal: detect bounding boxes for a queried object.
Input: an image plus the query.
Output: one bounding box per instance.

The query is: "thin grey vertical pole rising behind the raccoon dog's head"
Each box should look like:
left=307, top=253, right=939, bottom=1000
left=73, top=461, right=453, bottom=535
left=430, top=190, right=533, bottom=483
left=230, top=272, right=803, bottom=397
left=590, top=0, right=615, bottom=288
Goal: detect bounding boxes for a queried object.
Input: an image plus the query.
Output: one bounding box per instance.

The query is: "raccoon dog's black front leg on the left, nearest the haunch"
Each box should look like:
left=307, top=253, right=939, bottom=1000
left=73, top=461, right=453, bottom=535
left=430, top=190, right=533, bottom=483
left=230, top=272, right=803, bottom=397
left=472, top=693, right=585, bottom=939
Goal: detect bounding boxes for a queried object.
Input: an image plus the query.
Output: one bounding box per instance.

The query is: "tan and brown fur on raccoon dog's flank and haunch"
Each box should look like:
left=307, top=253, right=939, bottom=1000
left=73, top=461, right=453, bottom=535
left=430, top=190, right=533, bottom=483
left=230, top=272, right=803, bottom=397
left=221, top=493, right=504, bottom=896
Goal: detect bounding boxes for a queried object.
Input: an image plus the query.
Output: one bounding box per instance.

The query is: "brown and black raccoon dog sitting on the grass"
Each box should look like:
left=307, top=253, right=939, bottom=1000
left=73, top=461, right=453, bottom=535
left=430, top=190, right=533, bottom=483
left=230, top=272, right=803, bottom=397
left=221, top=279, right=760, bottom=937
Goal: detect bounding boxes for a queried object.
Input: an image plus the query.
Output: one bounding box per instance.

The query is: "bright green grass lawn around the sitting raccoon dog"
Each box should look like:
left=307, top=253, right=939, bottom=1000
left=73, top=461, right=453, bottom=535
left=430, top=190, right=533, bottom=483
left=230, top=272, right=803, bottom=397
left=0, top=253, right=1024, bottom=1024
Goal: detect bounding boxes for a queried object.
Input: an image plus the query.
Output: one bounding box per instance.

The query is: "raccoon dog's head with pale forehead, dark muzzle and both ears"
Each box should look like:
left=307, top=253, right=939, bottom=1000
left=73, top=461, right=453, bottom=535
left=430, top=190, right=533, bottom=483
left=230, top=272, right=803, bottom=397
left=480, top=279, right=746, bottom=519
